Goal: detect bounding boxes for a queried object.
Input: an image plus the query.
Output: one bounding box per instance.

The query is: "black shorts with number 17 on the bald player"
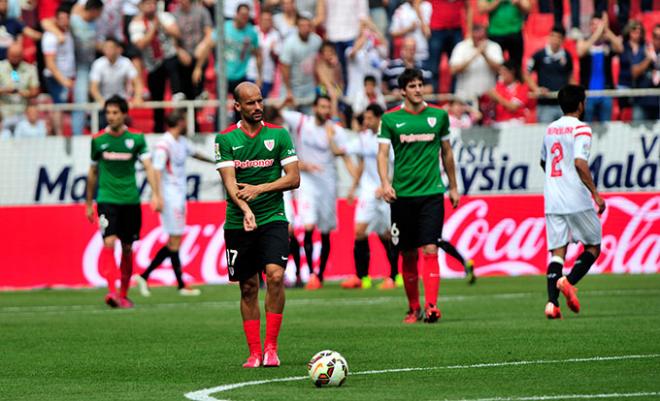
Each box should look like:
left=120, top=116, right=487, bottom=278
left=225, top=221, right=289, bottom=281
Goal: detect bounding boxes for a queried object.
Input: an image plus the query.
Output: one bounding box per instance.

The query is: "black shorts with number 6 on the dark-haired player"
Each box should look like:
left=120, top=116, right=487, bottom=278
left=390, top=195, right=445, bottom=250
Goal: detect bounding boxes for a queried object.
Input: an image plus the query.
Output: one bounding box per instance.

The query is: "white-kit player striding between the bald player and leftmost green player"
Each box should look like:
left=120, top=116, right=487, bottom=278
left=134, top=111, right=215, bottom=297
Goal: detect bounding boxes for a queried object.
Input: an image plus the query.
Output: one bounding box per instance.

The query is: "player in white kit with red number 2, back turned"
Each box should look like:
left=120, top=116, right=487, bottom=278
left=541, top=85, right=605, bottom=319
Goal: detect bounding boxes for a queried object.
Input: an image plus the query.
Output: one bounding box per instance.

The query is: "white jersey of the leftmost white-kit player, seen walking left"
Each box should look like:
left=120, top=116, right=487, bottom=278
left=153, top=132, right=195, bottom=196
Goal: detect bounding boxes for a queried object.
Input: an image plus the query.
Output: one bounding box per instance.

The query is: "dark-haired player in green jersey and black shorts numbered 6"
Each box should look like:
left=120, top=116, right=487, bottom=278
left=378, top=69, right=459, bottom=323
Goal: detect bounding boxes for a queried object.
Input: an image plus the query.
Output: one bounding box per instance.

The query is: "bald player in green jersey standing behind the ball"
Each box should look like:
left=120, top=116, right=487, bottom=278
left=215, top=82, right=300, bottom=368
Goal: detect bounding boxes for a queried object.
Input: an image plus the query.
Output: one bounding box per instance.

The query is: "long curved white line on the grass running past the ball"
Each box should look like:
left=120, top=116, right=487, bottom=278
left=184, top=354, right=660, bottom=401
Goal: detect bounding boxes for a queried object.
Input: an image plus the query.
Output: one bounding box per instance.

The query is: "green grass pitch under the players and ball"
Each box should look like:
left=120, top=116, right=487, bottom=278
left=0, top=275, right=660, bottom=401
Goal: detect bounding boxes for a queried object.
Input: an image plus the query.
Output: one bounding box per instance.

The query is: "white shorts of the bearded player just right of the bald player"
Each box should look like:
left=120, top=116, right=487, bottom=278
left=298, top=176, right=337, bottom=233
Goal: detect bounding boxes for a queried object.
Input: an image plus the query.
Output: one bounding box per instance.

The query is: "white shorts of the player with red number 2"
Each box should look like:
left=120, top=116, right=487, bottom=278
left=545, top=210, right=603, bottom=251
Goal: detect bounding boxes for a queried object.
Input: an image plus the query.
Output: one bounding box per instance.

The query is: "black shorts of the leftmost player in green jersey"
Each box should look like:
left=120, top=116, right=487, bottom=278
left=96, top=203, right=142, bottom=244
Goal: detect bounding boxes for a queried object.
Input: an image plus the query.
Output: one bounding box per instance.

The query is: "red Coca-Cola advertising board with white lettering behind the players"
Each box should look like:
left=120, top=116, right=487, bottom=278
left=0, top=193, right=660, bottom=289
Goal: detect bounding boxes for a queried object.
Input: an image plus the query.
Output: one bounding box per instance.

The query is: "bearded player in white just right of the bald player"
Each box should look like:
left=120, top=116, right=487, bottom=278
left=282, top=95, right=353, bottom=290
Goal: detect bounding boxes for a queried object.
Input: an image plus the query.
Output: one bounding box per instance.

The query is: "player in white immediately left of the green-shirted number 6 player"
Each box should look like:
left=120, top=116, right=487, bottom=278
left=341, top=104, right=403, bottom=289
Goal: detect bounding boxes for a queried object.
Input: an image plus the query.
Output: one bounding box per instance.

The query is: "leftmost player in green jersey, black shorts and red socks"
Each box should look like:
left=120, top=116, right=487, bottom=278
left=85, top=96, right=162, bottom=308
